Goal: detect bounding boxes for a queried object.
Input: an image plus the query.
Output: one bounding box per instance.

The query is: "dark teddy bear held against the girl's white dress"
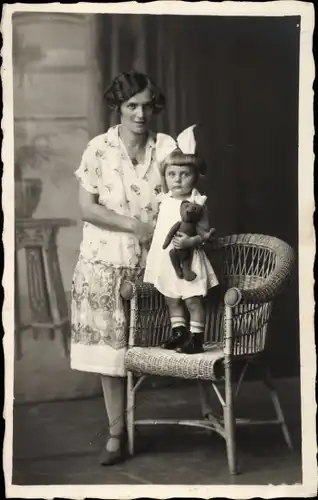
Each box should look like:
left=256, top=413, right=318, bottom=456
left=162, top=200, right=215, bottom=281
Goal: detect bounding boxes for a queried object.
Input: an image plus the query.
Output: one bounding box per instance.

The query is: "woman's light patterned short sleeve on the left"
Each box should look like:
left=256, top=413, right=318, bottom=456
left=74, top=143, right=100, bottom=194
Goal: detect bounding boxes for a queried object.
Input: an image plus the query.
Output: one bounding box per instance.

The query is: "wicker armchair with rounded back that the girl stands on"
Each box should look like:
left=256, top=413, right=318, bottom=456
left=121, top=234, right=294, bottom=474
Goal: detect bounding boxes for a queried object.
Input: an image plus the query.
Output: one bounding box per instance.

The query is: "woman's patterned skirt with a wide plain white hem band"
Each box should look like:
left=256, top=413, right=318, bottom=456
left=71, top=257, right=143, bottom=376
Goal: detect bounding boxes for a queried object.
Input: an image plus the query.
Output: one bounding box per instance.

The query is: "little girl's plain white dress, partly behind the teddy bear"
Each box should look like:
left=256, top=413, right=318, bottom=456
left=144, top=189, right=218, bottom=300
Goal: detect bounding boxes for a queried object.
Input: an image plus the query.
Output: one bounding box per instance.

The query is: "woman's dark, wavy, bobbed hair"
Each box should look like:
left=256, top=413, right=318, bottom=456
left=104, top=71, right=166, bottom=114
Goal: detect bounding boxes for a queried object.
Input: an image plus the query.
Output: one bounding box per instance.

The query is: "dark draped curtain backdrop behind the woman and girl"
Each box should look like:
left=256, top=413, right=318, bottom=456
left=96, top=14, right=300, bottom=375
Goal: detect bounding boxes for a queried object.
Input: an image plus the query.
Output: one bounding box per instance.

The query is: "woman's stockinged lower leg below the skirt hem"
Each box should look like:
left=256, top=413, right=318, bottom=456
left=101, top=375, right=126, bottom=451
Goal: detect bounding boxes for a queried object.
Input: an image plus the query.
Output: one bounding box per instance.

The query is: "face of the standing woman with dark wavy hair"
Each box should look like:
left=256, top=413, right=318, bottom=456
left=120, top=89, right=153, bottom=134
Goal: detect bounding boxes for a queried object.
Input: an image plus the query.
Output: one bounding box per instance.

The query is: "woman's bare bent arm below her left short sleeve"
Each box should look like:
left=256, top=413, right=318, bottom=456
left=79, top=186, right=138, bottom=233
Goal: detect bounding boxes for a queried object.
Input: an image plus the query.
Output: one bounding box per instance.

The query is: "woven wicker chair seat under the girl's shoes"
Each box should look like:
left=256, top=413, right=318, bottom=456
left=125, top=344, right=224, bottom=380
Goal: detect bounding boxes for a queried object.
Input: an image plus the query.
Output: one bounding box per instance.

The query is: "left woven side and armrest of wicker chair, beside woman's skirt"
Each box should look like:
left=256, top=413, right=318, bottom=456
left=120, top=281, right=171, bottom=347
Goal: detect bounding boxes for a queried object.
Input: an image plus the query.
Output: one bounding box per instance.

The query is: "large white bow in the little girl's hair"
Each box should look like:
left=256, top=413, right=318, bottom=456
left=156, top=125, right=196, bottom=163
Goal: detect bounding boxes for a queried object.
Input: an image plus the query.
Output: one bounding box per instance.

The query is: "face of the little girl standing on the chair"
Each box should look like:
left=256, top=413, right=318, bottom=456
left=165, top=165, right=197, bottom=198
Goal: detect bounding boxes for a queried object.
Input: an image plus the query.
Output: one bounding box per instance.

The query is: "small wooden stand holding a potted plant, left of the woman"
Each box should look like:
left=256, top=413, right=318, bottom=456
left=14, top=219, right=76, bottom=359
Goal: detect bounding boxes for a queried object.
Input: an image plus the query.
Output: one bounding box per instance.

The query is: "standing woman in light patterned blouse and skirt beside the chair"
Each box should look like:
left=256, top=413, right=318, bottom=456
left=71, top=71, right=165, bottom=465
